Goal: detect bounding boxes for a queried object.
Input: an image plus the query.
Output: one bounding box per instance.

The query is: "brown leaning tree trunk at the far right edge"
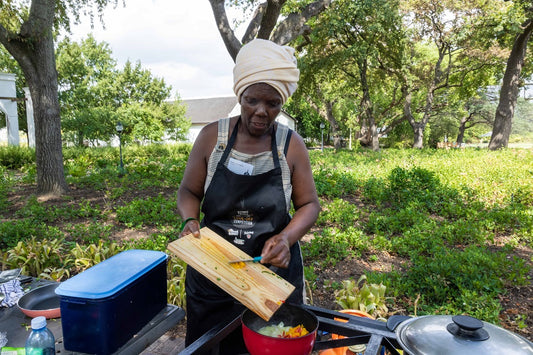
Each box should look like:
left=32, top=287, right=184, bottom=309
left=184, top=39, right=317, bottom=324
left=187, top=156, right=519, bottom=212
left=489, top=19, right=533, bottom=150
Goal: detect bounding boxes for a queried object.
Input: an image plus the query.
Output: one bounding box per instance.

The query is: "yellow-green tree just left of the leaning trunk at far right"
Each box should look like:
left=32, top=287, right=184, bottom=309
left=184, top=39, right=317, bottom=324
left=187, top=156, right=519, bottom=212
left=394, top=0, right=508, bottom=148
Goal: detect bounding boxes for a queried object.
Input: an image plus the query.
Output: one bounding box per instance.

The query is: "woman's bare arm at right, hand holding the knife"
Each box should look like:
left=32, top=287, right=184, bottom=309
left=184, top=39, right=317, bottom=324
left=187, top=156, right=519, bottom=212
left=261, top=132, right=320, bottom=268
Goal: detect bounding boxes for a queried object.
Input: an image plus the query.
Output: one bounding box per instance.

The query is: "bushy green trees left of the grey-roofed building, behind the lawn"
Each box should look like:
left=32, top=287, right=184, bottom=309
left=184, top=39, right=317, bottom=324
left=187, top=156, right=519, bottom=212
left=57, top=36, right=189, bottom=145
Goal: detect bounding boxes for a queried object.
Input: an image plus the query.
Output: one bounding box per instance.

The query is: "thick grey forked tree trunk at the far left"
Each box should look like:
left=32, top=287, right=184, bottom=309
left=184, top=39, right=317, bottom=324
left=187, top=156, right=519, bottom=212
left=0, top=0, right=68, bottom=196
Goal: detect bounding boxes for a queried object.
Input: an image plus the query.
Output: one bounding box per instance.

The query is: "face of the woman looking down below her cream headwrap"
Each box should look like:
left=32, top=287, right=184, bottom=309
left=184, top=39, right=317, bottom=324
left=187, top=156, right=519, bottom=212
left=240, top=83, right=283, bottom=136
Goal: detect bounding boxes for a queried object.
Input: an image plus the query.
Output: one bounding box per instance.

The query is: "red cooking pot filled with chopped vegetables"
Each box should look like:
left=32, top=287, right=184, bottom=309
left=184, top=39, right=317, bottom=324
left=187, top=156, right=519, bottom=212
left=241, top=304, right=318, bottom=355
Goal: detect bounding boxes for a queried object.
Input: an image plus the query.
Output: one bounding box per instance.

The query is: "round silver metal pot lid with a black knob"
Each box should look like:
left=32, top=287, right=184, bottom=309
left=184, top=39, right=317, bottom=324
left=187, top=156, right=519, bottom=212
left=396, top=316, right=533, bottom=355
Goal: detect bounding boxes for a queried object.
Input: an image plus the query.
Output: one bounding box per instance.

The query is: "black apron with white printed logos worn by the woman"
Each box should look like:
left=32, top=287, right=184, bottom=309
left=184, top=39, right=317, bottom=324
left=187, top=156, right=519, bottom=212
left=185, top=118, right=304, bottom=354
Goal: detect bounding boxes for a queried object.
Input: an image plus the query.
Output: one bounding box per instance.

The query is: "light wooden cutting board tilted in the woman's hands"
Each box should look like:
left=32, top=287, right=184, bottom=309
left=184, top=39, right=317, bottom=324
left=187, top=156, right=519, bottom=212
left=168, top=227, right=295, bottom=321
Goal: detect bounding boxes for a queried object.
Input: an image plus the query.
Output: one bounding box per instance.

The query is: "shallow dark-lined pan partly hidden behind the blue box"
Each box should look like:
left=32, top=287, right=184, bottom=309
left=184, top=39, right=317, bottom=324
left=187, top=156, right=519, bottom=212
left=17, top=282, right=61, bottom=319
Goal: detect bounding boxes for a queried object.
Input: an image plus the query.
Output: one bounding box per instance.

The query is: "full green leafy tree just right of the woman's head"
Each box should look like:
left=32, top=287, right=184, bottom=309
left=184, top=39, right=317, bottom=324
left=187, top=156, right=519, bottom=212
left=301, top=0, right=403, bottom=150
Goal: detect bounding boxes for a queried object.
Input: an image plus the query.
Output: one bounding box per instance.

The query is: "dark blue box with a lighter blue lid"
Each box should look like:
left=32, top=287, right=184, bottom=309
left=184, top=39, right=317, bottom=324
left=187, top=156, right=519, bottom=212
left=55, top=250, right=167, bottom=354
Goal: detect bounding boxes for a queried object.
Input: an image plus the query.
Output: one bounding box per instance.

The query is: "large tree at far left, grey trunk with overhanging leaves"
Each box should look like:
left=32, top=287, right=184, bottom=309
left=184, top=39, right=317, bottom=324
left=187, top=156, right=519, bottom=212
left=0, top=0, right=116, bottom=195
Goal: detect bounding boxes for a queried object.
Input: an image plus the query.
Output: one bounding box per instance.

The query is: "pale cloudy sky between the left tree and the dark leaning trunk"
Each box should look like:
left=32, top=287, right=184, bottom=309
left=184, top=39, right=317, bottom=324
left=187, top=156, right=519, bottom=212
left=66, top=0, right=239, bottom=99
